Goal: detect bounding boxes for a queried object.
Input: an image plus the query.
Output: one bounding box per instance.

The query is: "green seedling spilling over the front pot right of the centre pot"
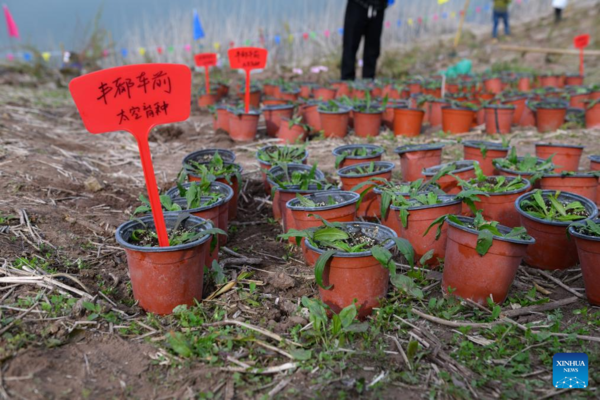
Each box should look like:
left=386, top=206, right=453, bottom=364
left=423, top=212, right=531, bottom=256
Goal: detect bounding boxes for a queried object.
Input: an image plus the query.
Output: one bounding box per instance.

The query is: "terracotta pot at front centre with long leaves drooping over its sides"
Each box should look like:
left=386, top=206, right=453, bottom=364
left=304, top=222, right=396, bottom=319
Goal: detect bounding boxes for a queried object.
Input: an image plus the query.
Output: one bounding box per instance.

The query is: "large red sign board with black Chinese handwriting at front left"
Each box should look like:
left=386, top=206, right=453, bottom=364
left=69, top=64, right=192, bottom=137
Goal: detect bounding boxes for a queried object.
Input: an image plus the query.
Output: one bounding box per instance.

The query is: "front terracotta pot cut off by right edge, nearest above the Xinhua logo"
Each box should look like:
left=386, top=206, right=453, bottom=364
left=569, top=220, right=600, bottom=306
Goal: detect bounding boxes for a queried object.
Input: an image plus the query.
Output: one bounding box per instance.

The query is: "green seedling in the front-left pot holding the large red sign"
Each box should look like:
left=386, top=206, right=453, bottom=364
left=129, top=212, right=227, bottom=248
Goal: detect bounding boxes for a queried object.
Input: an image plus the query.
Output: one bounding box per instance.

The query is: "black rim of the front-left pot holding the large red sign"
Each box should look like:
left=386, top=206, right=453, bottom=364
left=115, top=212, right=213, bottom=253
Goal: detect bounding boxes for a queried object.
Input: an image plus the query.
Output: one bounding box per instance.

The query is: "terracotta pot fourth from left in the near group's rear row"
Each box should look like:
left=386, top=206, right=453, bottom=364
left=394, top=143, right=444, bottom=182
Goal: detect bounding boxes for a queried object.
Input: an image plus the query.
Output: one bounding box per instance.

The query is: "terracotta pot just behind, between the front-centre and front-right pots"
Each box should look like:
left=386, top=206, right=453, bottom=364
left=390, top=196, right=462, bottom=267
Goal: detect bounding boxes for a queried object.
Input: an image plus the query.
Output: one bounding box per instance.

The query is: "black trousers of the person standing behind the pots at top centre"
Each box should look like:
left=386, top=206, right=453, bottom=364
left=342, top=0, right=385, bottom=80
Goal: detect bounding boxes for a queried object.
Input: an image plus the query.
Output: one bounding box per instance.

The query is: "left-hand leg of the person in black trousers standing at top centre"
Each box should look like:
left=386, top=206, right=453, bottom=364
left=342, top=0, right=367, bottom=80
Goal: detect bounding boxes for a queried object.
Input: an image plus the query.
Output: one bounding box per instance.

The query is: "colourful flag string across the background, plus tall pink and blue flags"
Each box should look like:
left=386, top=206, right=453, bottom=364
left=3, top=0, right=529, bottom=63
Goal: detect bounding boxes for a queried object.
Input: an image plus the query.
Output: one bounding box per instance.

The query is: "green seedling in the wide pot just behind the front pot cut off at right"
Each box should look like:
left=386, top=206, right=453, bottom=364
left=521, top=189, right=589, bottom=222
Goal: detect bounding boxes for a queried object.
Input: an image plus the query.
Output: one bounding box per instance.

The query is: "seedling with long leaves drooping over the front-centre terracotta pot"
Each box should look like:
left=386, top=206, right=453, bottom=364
left=279, top=215, right=424, bottom=299
